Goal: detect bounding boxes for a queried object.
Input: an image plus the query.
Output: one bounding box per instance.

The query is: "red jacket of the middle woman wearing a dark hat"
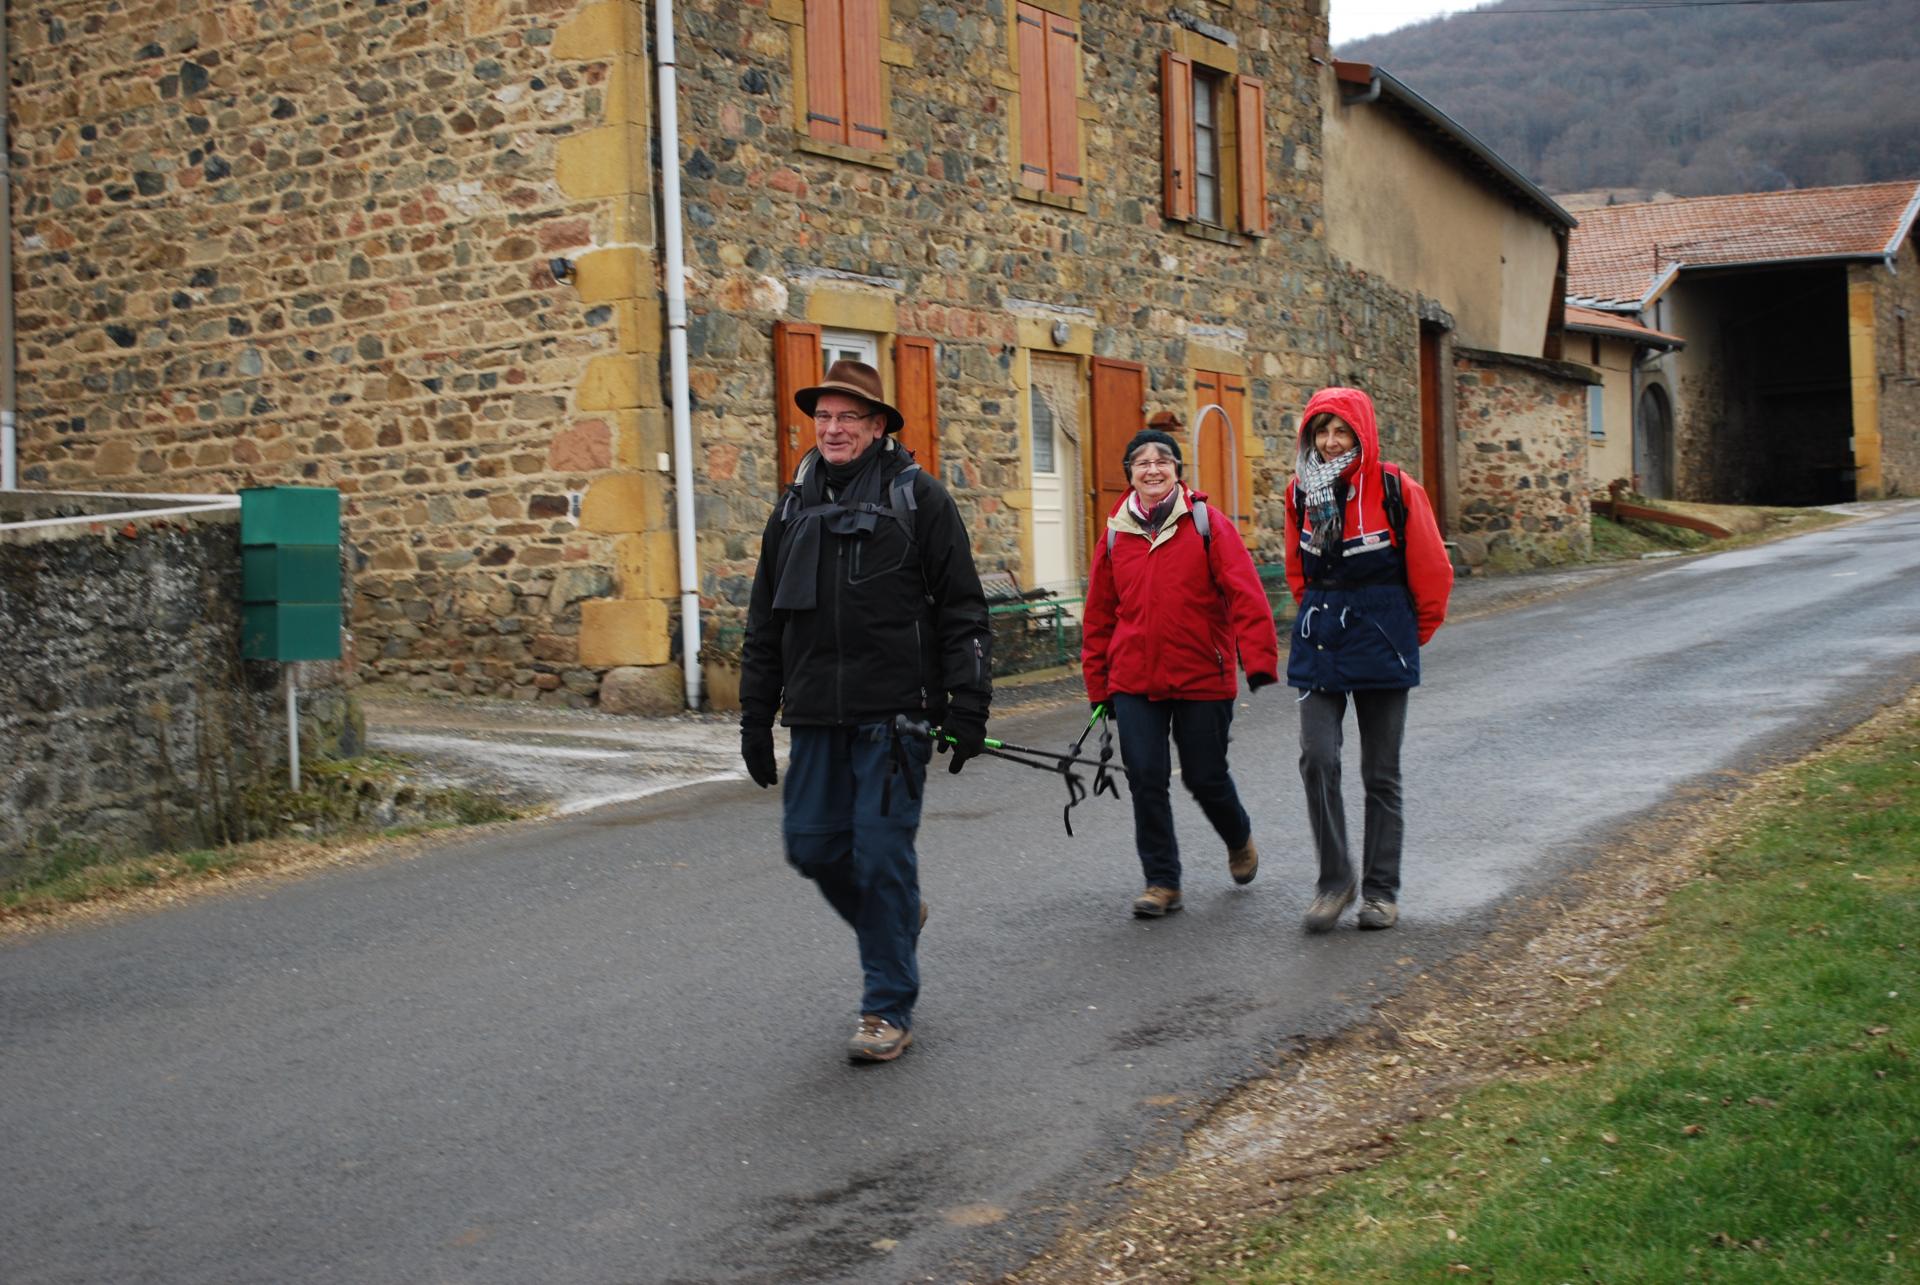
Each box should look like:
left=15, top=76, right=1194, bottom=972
left=1081, top=486, right=1281, bottom=701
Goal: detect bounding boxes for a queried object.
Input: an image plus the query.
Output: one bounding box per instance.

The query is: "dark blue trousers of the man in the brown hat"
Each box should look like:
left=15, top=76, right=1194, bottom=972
left=781, top=722, right=933, bottom=1031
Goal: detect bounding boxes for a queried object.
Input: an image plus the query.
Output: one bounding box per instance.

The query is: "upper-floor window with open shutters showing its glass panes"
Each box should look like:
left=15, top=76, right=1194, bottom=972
left=1160, top=50, right=1267, bottom=236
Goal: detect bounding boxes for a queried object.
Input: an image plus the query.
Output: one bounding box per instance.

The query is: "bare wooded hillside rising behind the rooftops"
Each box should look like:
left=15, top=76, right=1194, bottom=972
left=1336, top=0, right=1920, bottom=196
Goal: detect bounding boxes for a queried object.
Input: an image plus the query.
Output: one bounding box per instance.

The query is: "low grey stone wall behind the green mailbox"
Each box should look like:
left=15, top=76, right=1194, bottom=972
left=0, top=494, right=357, bottom=880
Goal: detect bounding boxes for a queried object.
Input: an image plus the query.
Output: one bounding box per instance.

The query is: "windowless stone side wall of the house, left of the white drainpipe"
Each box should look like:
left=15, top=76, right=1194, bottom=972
left=8, top=0, right=659, bottom=703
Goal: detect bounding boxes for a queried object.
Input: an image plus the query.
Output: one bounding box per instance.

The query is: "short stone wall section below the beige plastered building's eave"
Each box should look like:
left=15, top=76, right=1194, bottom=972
left=1453, top=348, right=1599, bottom=570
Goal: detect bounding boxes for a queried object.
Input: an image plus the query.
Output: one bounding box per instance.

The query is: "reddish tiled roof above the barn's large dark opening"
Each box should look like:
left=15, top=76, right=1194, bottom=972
left=1567, top=179, right=1920, bottom=303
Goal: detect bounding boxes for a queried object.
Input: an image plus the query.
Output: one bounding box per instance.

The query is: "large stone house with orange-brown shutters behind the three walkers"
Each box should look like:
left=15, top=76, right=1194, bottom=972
left=8, top=0, right=1474, bottom=709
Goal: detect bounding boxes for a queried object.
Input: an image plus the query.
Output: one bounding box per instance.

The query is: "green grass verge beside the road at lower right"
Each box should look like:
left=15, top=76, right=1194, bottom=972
left=1210, top=716, right=1920, bottom=1285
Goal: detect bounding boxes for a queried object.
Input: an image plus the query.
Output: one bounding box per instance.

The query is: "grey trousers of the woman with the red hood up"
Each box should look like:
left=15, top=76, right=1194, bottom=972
left=1300, top=688, right=1407, bottom=901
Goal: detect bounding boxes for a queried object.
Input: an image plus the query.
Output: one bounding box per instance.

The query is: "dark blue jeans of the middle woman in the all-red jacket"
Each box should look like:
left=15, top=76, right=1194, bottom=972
left=1114, top=693, right=1254, bottom=887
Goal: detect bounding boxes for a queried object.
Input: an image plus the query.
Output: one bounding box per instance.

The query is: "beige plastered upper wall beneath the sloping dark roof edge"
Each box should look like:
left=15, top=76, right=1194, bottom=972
left=1323, top=71, right=1559, bottom=357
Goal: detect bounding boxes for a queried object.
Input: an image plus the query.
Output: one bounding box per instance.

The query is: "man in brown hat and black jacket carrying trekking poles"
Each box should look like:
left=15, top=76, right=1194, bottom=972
left=739, top=361, right=993, bottom=1062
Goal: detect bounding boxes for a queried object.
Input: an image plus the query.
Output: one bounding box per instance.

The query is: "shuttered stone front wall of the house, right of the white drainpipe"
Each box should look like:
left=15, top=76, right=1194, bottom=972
left=680, top=0, right=1329, bottom=610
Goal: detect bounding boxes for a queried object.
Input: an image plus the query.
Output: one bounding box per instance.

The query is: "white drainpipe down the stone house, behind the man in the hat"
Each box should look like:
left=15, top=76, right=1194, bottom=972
left=653, top=0, right=701, bottom=709
